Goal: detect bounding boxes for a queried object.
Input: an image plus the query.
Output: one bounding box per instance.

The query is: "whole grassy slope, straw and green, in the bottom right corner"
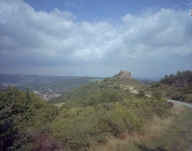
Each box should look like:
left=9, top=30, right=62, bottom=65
left=90, top=104, right=192, bottom=151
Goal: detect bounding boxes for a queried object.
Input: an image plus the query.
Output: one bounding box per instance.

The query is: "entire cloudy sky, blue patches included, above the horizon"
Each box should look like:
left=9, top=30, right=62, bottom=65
left=0, top=0, right=192, bottom=78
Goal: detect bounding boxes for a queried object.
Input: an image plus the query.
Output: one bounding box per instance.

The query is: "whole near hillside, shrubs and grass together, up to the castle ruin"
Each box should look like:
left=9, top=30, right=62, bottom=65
left=0, top=71, right=192, bottom=151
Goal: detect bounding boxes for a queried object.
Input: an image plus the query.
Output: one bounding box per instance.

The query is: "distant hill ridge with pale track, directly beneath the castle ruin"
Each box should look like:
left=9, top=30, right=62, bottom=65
left=49, top=71, right=144, bottom=103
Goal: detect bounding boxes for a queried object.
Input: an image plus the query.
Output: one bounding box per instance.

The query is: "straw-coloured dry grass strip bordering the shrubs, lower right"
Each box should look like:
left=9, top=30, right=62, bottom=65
left=90, top=104, right=185, bottom=151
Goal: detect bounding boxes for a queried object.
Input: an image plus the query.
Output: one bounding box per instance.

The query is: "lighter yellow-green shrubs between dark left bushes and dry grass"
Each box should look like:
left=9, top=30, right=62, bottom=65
left=52, top=94, right=172, bottom=150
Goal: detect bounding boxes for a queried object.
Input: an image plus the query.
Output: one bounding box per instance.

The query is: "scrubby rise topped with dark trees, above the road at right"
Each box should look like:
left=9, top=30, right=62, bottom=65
left=145, top=70, right=192, bottom=102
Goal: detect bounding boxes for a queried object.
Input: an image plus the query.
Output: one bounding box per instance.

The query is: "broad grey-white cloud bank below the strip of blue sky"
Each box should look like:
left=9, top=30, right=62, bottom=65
left=0, top=0, right=192, bottom=76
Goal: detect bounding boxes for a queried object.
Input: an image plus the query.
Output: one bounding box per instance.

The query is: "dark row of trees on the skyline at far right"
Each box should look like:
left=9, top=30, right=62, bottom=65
left=161, top=70, right=192, bottom=87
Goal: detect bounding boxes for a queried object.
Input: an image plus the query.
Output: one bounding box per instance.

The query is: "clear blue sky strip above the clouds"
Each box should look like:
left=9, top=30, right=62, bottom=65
left=24, top=0, right=188, bottom=21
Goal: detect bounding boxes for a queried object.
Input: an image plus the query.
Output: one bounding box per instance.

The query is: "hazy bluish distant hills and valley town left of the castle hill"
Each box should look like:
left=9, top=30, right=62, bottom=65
left=0, top=74, right=103, bottom=100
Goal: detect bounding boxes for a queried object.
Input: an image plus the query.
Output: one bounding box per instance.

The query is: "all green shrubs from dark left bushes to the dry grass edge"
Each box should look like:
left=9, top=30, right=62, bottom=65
left=0, top=84, right=172, bottom=151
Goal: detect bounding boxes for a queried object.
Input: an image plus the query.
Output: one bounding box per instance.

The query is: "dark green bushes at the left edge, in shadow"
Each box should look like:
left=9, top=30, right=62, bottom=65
left=0, top=87, right=57, bottom=150
